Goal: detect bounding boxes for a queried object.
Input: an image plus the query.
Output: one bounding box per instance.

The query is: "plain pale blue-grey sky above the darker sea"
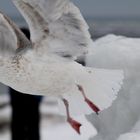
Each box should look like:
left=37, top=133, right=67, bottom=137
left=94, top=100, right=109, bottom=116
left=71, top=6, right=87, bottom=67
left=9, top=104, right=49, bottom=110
left=0, top=0, right=140, bottom=18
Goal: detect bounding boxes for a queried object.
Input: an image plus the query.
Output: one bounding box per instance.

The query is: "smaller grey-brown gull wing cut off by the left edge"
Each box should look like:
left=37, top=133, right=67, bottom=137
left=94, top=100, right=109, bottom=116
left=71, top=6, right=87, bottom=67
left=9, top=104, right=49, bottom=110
left=0, top=12, right=30, bottom=56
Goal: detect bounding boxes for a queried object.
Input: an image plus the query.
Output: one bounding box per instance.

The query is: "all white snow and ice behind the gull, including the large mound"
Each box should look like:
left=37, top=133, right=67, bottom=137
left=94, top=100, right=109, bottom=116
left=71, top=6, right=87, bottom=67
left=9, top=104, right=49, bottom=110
left=0, top=35, right=140, bottom=140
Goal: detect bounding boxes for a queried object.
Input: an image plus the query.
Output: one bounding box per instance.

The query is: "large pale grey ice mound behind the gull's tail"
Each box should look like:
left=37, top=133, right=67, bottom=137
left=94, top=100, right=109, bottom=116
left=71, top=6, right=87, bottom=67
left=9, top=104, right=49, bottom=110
left=87, top=35, right=140, bottom=140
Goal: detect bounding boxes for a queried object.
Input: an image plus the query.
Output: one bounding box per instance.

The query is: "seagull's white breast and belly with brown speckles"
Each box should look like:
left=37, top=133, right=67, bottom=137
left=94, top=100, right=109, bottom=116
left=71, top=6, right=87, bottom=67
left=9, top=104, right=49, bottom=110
left=0, top=52, right=81, bottom=96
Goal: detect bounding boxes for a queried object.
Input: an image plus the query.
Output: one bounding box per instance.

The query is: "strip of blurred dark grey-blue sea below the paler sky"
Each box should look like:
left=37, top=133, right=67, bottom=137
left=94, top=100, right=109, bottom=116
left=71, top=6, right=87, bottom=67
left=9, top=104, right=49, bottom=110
left=12, top=17, right=140, bottom=39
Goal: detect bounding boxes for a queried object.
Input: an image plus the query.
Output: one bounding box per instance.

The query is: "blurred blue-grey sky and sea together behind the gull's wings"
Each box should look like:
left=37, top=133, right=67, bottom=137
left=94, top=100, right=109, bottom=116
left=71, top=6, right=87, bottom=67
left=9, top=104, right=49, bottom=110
left=0, top=0, right=140, bottom=39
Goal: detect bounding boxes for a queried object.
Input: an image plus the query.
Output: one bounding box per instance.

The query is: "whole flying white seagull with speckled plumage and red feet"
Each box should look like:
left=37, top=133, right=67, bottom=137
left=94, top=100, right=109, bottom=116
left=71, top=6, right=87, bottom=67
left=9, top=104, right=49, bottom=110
left=0, top=0, right=123, bottom=134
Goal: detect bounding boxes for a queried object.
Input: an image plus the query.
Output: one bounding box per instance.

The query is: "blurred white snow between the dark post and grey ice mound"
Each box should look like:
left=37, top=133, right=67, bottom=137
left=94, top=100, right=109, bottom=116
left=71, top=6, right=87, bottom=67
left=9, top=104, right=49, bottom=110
left=40, top=99, right=97, bottom=140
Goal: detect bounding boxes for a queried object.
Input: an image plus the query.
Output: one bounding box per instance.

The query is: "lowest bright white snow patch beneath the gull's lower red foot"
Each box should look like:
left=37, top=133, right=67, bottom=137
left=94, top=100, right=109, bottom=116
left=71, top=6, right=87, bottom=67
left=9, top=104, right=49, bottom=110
left=41, top=116, right=97, bottom=140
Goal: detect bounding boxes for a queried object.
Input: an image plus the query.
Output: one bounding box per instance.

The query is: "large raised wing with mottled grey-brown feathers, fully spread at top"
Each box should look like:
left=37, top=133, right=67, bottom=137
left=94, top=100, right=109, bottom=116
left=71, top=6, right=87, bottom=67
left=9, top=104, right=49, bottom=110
left=13, top=0, right=91, bottom=57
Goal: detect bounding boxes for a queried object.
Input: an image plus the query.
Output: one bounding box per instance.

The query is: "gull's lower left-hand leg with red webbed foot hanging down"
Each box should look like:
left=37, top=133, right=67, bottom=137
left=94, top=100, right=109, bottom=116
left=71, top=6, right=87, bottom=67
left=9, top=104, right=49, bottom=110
left=62, top=98, right=81, bottom=134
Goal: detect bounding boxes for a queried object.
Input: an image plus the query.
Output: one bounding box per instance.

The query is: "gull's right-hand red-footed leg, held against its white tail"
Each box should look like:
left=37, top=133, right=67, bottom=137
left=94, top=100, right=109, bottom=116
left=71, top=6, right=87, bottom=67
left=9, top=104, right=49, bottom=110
left=77, top=85, right=100, bottom=115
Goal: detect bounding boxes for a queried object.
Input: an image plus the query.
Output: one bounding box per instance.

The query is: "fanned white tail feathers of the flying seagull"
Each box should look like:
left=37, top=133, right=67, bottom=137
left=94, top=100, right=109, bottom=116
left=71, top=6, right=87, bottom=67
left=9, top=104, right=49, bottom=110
left=59, top=68, right=123, bottom=115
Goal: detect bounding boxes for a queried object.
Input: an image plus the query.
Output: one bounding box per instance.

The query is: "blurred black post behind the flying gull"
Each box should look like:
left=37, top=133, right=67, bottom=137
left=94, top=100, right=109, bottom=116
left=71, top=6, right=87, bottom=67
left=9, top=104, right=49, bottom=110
left=9, top=29, right=40, bottom=140
